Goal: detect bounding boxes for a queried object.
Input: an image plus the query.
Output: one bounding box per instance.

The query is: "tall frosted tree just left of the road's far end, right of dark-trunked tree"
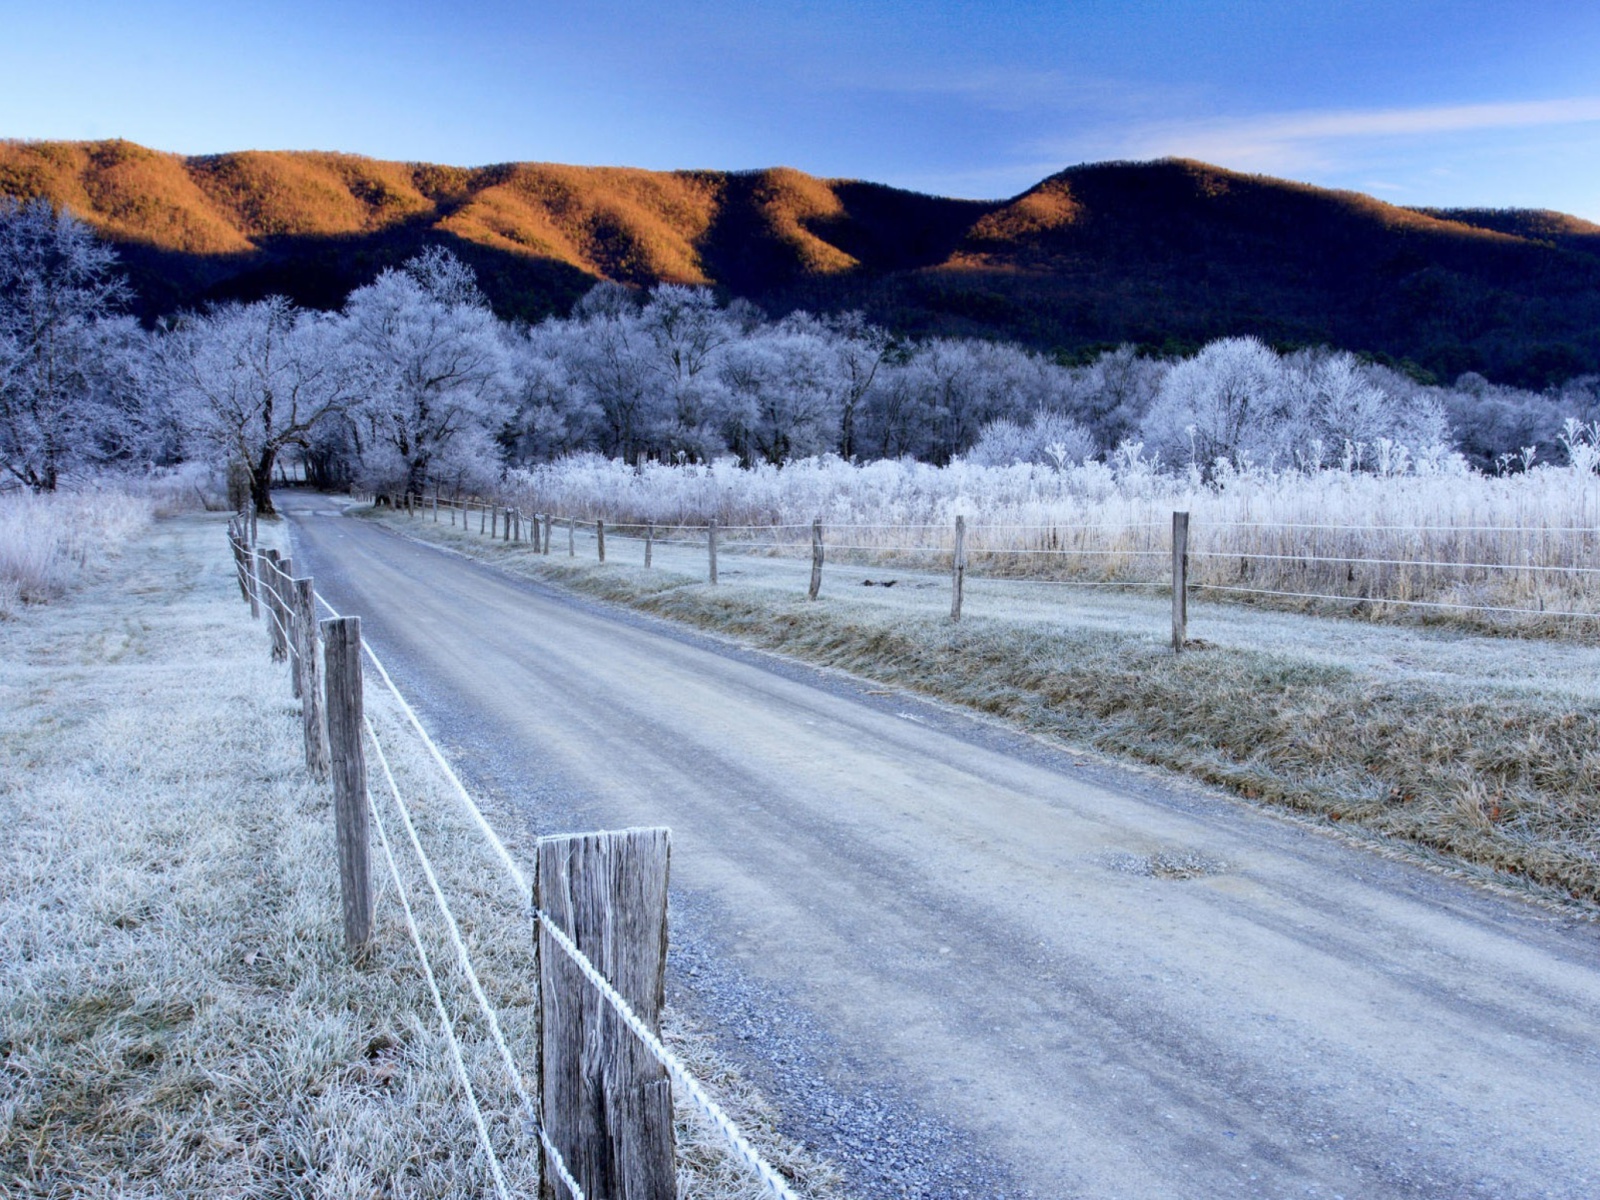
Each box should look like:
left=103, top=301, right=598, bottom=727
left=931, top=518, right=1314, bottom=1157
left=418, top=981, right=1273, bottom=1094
left=344, top=250, right=514, bottom=494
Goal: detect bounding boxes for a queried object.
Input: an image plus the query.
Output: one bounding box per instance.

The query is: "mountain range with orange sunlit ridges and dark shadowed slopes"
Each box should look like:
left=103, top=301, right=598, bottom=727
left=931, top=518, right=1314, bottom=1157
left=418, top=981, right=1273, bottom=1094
left=0, top=141, right=1600, bottom=387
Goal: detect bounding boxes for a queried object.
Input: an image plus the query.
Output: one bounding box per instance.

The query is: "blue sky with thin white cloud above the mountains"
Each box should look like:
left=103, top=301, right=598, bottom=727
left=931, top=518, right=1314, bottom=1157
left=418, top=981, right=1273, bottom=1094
left=9, top=0, right=1600, bottom=221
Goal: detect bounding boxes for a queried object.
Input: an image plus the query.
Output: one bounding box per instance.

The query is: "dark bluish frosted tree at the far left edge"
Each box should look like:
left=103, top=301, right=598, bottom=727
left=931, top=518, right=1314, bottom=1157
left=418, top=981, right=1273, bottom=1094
left=0, top=200, right=142, bottom=491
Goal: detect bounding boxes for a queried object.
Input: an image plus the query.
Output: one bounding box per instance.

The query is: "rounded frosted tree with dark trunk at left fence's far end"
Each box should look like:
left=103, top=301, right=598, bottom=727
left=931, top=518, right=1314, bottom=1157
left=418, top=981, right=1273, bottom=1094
left=160, top=296, right=368, bottom=512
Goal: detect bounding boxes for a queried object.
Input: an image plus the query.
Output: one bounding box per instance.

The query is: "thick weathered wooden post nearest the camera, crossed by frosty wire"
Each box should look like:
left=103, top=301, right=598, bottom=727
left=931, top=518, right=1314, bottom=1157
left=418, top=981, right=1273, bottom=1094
left=534, top=829, right=677, bottom=1200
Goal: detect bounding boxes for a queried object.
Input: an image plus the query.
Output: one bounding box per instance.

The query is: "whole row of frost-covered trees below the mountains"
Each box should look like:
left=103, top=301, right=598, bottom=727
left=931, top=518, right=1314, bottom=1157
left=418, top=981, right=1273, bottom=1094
left=0, top=202, right=1600, bottom=509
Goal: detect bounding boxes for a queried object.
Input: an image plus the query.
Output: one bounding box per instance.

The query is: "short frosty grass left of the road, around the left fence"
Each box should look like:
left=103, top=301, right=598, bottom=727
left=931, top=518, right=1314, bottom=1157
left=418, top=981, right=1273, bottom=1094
left=0, top=515, right=844, bottom=1200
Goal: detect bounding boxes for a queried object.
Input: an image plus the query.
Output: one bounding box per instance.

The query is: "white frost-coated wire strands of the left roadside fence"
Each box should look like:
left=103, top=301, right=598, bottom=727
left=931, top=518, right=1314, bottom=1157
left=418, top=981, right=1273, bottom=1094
left=229, top=518, right=812, bottom=1200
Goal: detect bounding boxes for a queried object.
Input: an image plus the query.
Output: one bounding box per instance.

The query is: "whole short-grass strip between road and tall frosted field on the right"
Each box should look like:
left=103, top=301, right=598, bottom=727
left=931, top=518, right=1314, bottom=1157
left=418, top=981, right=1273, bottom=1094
left=381, top=492, right=1600, bottom=902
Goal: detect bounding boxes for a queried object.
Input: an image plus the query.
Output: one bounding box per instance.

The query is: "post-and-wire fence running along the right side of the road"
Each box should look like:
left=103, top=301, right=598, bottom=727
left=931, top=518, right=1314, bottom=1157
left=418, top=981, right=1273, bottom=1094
left=368, top=496, right=1600, bottom=646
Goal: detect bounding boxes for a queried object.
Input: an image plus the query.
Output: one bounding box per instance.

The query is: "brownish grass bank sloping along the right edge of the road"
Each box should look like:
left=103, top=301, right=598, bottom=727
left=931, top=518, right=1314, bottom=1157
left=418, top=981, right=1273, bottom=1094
left=363, top=517, right=1600, bottom=906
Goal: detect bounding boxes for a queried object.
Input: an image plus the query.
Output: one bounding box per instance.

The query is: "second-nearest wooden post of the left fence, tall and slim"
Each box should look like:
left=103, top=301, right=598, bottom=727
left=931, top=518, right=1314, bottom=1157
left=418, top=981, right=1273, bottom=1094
left=322, top=616, right=373, bottom=952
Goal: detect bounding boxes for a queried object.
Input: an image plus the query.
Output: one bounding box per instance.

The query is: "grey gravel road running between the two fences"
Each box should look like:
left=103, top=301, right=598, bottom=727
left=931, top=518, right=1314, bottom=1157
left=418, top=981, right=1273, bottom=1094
left=285, top=496, right=1600, bottom=1200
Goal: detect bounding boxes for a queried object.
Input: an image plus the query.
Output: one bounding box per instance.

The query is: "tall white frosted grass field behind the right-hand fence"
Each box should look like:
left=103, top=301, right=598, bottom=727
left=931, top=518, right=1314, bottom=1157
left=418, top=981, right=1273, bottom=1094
left=501, top=454, right=1600, bottom=640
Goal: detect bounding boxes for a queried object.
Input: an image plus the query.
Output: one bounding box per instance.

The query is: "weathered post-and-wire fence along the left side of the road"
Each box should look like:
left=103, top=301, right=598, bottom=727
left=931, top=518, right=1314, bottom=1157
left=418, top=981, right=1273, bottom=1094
left=227, top=515, right=797, bottom=1200
